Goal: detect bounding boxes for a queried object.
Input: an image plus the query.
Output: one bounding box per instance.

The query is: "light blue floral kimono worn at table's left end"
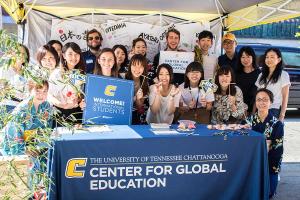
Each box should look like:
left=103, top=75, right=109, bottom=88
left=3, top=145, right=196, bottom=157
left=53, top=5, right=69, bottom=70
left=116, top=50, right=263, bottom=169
left=3, top=97, right=52, bottom=186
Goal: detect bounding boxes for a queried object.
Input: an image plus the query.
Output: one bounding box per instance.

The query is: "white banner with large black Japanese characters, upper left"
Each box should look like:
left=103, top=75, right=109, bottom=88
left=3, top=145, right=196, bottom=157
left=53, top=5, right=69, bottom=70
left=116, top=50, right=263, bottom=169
left=51, top=19, right=101, bottom=51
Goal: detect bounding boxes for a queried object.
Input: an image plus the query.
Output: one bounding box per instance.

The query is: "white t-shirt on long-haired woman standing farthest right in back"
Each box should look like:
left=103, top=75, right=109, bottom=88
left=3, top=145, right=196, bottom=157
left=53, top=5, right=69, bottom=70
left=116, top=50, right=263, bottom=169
left=255, top=71, right=291, bottom=109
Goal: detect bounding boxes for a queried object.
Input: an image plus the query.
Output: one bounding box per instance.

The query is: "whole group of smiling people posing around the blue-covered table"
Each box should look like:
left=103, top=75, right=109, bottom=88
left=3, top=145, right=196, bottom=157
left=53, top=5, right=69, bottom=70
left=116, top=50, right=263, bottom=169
left=0, top=29, right=290, bottom=196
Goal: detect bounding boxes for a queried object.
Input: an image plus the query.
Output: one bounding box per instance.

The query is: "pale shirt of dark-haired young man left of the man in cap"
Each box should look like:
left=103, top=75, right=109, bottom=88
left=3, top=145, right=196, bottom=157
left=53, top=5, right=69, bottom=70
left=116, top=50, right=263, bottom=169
left=202, top=54, right=218, bottom=80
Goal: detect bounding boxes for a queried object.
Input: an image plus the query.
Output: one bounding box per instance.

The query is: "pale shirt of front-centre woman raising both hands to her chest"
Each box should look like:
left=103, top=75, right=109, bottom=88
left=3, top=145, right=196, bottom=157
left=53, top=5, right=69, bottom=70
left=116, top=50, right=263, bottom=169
left=146, top=85, right=181, bottom=124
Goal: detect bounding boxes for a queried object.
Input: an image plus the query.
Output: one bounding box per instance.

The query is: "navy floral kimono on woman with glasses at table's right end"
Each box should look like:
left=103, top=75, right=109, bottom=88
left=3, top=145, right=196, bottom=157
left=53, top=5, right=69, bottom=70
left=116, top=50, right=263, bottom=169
left=249, top=113, right=284, bottom=174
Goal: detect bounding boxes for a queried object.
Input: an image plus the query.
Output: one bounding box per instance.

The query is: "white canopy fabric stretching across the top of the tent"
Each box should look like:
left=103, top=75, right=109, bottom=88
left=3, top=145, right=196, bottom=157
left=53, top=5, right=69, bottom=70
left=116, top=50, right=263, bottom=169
left=22, top=0, right=266, bottom=14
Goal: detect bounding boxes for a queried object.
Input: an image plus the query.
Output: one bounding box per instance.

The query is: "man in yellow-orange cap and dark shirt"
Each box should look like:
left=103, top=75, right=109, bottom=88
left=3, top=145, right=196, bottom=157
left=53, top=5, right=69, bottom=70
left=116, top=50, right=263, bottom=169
left=218, top=33, right=238, bottom=72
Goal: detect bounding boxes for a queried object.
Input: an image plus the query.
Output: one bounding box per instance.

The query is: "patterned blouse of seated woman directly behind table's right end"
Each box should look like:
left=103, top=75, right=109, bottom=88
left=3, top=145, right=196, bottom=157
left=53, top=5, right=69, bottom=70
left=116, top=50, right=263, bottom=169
left=211, top=86, right=248, bottom=124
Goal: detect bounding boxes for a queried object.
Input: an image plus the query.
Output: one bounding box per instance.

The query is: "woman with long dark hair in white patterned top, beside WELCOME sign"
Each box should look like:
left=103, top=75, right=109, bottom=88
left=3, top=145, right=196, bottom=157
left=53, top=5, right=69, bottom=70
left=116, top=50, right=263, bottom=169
left=48, top=42, right=86, bottom=123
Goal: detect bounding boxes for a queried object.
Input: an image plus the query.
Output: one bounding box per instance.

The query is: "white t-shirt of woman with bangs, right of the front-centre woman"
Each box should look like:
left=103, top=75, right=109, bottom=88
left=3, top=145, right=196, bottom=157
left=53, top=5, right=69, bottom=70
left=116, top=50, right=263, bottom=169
left=179, top=83, right=215, bottom=108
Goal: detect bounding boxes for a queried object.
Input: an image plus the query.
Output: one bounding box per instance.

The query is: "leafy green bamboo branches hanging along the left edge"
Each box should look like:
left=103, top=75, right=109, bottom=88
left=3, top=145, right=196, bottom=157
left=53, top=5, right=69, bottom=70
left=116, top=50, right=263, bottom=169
left=0, top=30, right=85, bottom=199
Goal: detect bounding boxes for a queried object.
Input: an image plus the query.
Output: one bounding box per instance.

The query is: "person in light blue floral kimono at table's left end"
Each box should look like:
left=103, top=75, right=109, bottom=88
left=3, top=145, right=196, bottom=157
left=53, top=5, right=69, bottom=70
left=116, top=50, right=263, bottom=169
left=3, top=80, right=53, bottom=194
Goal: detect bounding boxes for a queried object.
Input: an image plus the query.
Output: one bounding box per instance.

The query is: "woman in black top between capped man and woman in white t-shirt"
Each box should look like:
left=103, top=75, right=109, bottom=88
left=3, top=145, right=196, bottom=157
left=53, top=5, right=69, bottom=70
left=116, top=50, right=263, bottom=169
left=236, top=46, right=260, bottom=114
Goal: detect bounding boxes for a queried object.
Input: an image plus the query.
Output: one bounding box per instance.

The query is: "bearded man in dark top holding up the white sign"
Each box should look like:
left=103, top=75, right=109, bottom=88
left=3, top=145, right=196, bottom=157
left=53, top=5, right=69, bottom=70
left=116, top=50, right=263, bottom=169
left=148, top=28, right=185, bottom=85
